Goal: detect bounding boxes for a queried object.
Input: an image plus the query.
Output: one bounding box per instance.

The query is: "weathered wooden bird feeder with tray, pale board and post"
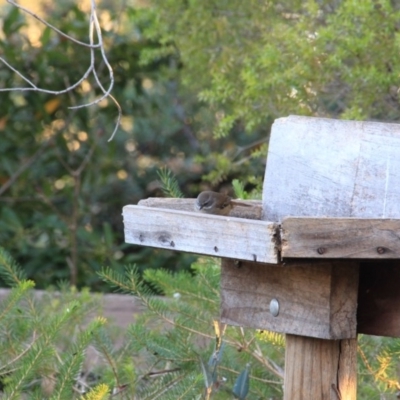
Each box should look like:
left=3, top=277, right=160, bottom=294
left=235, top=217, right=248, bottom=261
left=123, top=116, right=400, bottom=400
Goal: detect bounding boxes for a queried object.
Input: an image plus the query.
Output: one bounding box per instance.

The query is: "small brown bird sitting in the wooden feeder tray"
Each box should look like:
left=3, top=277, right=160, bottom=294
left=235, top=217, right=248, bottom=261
left=194, top=190, right=252, bottom=215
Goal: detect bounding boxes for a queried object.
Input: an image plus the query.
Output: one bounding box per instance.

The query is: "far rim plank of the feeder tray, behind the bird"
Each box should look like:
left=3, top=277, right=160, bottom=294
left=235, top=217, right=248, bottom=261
left=138, top=197, right=262, bottom=220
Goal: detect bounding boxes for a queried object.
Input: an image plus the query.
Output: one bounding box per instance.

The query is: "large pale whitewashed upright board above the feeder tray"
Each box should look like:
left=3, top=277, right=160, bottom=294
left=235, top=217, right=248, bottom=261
left=263, top=116, right=400, bottom=222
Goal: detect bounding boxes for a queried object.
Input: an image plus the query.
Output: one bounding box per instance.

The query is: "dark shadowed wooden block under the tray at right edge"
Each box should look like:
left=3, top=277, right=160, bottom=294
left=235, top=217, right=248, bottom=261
left=357, top=261, right=400, bottom=337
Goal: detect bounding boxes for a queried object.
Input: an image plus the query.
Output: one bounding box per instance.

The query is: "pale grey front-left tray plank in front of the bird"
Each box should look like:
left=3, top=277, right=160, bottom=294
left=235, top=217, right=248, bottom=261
left=123, top=205, right=278, bottom=263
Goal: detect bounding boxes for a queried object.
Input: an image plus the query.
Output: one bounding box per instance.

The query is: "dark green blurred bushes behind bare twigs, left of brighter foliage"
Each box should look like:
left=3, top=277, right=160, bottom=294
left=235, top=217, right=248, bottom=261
left=0, top=0, right=266, bottom=291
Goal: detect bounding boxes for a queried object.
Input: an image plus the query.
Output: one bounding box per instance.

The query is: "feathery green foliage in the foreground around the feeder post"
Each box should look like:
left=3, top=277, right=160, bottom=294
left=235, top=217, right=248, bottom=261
left=0, top=249, right=399, bottom=400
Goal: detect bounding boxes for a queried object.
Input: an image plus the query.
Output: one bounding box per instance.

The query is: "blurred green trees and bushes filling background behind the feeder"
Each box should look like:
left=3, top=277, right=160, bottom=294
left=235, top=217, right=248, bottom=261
left=0, top=0, right=400, bottom=290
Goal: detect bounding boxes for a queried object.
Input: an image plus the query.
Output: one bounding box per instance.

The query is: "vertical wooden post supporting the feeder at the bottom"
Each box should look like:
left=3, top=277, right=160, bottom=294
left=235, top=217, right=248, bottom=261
left=284, top=335, right=357, bottom=400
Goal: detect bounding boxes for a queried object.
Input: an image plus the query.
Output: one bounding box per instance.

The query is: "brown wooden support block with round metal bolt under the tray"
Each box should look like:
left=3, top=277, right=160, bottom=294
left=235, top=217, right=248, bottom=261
left=221, top=260, right=358, bottom=339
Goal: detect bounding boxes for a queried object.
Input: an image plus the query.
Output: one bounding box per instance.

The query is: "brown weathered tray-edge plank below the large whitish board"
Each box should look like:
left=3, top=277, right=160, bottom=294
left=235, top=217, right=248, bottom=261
left=281, top=217, right=400, bottom=260
